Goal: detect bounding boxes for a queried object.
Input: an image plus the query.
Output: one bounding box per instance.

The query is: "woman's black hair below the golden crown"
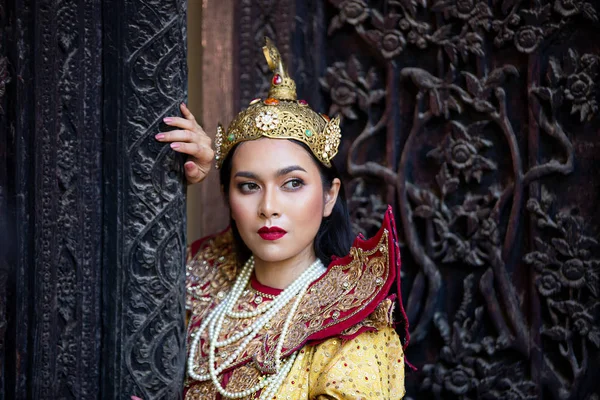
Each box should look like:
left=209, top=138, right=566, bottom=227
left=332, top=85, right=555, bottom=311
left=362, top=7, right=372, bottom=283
left=219, top=139, right=353, bottom=266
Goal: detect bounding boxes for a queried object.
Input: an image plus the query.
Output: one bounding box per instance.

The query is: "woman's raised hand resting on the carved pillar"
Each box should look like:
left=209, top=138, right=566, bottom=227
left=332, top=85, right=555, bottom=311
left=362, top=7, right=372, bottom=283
left=155, top=103, right=215, bottom=183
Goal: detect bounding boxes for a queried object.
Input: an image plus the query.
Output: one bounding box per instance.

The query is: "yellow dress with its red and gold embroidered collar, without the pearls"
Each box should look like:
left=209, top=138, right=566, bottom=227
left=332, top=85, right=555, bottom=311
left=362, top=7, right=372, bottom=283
left=185, top=206, right=405, bottom=400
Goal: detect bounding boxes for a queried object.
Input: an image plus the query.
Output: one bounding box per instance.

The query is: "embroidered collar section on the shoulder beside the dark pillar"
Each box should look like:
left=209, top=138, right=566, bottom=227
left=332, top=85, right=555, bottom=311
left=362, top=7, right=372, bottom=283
left=186, top=228, right=238, bottom=313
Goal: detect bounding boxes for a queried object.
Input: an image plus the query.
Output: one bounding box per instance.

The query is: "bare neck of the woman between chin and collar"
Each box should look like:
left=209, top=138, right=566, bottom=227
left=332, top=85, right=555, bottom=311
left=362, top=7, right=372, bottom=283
left=254, top=246, right=317, bottom=289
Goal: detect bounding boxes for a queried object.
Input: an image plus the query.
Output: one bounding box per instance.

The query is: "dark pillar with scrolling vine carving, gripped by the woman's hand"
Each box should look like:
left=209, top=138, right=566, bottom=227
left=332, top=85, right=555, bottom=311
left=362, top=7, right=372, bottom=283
left=102, top=0, right=187, bottom=399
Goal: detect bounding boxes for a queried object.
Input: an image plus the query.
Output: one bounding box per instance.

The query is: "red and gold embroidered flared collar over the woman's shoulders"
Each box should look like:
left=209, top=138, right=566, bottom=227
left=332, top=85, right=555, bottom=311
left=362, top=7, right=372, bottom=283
left=187, top=209, right=399, bottom=372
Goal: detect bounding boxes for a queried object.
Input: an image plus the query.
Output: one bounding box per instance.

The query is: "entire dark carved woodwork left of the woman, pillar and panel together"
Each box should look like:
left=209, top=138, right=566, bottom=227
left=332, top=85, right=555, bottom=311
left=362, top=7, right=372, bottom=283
left=0, top=0, right=187, bottom=399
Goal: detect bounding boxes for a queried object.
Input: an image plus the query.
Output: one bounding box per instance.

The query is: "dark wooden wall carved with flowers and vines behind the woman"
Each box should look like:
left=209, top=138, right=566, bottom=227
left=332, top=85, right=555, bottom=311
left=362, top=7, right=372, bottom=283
left=238, top=0, right=600, bottom=400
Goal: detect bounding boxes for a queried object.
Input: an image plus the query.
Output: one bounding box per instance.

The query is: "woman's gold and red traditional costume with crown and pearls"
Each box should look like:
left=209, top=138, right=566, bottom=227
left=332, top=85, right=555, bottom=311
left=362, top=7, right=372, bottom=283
left=185, top=39, right=408, bottom=400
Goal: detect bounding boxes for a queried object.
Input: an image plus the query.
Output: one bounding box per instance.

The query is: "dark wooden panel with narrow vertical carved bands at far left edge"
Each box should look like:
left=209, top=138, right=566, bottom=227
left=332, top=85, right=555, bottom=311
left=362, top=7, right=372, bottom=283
left=0, top=1, right=102, bottom=399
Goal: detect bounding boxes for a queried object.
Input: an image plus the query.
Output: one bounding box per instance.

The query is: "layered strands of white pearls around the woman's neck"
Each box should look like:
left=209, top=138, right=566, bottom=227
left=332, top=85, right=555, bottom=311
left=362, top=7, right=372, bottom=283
left=188, top=257, right=326, bottom=399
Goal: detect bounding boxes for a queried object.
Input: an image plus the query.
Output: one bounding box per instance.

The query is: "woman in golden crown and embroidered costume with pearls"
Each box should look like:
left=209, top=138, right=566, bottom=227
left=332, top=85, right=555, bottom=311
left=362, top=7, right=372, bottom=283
left=157, top=39, right=407, bottom=399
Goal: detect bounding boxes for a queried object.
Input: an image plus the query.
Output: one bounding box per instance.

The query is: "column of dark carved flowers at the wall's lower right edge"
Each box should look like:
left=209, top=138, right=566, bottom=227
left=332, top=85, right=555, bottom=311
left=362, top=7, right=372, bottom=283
left=525, top=186, right=600, bottom=398
